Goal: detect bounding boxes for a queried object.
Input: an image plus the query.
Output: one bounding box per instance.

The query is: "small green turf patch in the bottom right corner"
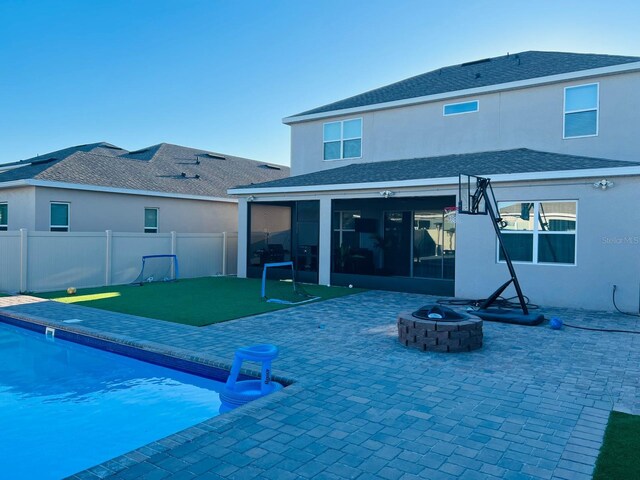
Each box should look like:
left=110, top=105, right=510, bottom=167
left=593, top=412, right=640, bottom=480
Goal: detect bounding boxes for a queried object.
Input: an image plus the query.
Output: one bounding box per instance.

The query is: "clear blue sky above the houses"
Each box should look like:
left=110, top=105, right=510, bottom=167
left=0, top=0, right=640, bottom=164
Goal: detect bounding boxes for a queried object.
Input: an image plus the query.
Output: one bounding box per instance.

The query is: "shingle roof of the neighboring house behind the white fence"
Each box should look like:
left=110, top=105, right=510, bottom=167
left=0, top=143, right=289, bottom=197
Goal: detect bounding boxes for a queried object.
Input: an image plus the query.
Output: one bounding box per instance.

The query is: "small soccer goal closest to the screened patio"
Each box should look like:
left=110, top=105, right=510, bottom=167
left=261, top=262, right=320, bottom=305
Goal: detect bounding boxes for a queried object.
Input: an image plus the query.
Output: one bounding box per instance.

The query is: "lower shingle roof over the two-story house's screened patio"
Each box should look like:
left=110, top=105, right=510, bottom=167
left=234, top=148, right=640, bottom=188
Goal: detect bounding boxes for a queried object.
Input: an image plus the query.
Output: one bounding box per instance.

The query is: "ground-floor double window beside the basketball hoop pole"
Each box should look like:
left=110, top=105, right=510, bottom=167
left=498, top=201, right=577, bottom=265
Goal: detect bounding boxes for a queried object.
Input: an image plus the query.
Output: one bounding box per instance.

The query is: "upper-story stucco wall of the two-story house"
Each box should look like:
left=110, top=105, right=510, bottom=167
left=291, top=72, right=640, bottom=175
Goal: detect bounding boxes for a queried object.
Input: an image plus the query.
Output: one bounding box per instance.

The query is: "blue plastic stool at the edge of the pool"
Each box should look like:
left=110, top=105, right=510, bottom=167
left=220, top=344, right=282, bottom=413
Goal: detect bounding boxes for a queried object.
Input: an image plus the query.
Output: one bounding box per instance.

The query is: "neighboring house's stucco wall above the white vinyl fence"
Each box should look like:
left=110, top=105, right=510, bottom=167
left=30, top=187, right=238, bottom=233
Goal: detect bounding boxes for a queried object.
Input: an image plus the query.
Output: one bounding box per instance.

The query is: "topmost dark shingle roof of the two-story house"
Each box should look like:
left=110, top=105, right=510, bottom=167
left=298, top=51, right=640, bottom=115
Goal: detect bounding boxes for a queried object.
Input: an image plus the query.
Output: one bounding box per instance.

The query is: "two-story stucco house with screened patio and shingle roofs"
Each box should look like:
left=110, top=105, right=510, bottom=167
left=230, top=51, right=640, bottom=311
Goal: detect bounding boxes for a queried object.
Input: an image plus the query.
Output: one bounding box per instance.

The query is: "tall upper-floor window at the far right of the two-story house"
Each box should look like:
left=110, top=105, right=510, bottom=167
left=564, top=83, right=598, bottom=138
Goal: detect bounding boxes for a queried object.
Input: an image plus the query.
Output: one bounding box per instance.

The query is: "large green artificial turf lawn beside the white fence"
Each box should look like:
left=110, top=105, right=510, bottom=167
left=36, top=277, right=363, bottom=327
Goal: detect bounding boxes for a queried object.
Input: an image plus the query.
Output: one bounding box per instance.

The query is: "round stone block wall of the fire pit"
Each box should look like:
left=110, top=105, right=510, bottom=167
left=398, top=312, right=482, bottom=352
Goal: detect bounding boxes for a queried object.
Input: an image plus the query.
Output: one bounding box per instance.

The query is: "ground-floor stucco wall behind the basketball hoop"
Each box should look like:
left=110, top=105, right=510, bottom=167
left=456, top=177, right=640, bottom=312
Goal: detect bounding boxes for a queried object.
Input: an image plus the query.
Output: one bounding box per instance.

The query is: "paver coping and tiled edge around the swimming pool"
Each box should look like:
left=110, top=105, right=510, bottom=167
left=0, top=311, right=302, bottom=479
